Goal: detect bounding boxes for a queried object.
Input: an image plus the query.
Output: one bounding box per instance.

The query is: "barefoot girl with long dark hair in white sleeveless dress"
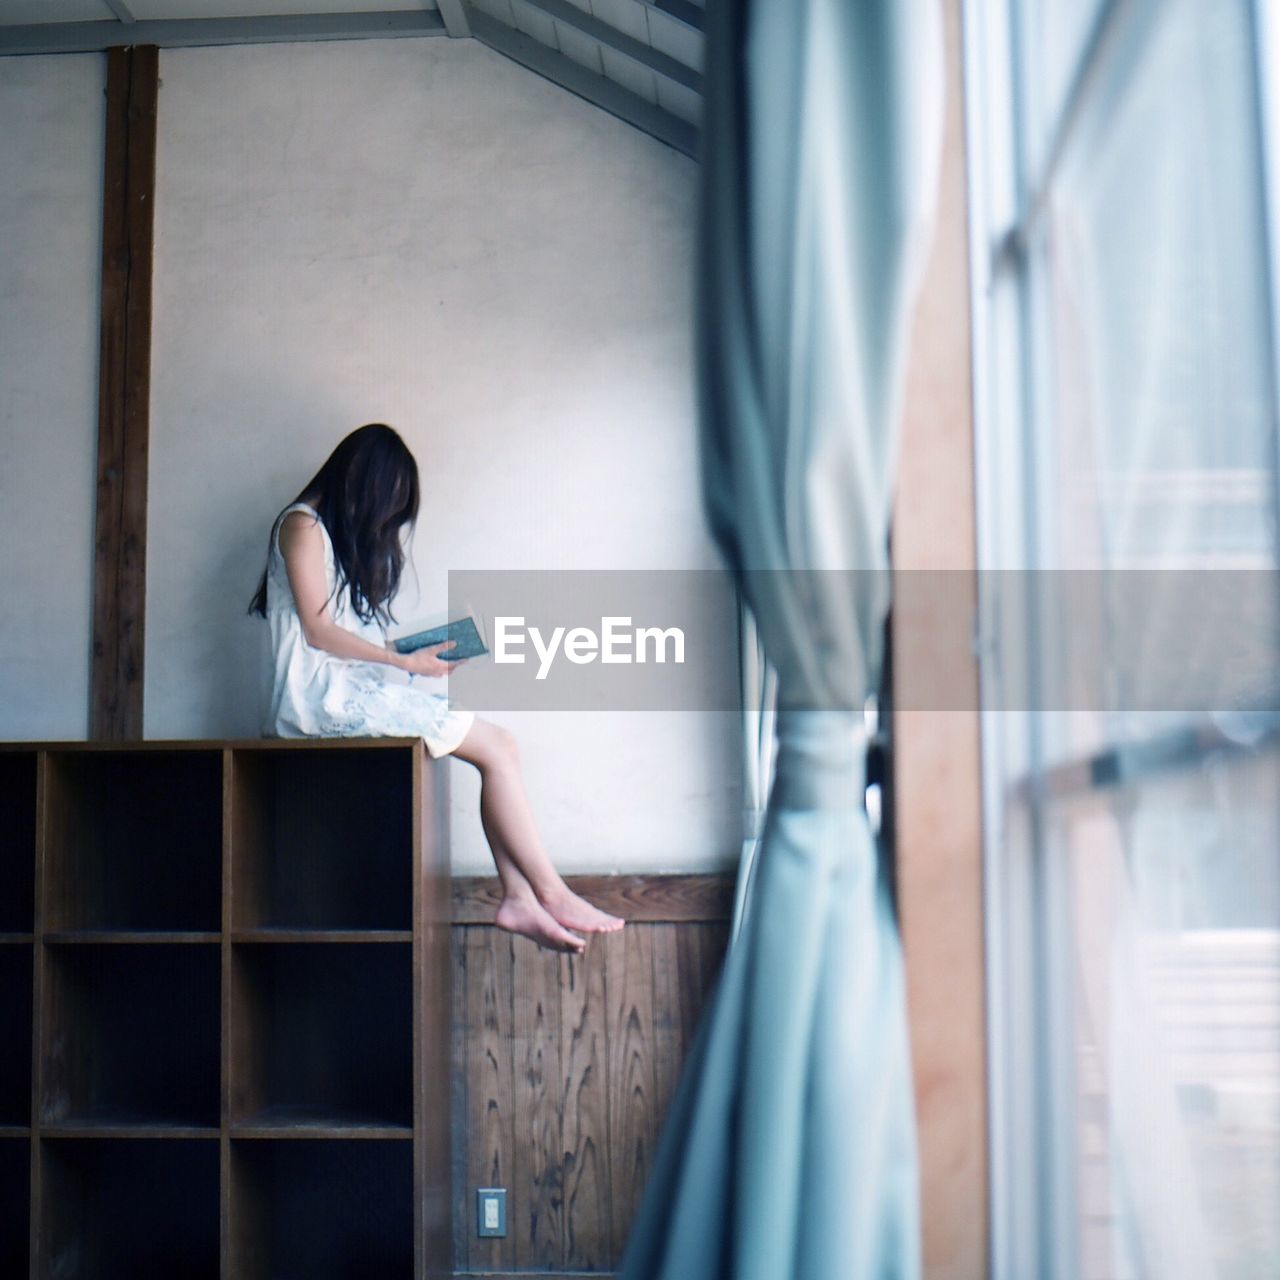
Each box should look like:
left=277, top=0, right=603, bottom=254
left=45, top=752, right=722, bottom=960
left=250, top=422, right=625, bottom=954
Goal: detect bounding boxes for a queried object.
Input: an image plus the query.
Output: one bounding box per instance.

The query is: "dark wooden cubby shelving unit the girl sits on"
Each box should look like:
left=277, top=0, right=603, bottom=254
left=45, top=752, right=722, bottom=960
left=0, top=739, right=453, bottom=1280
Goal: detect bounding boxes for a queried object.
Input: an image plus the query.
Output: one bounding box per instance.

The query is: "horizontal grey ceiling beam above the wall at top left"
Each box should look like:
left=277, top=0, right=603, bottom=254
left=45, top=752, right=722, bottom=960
left=0, top=9, right=447, bottom=55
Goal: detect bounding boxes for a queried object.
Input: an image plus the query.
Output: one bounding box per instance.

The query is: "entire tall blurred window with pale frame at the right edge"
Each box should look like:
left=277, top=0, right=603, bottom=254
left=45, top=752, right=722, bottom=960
left=968, top=0, right=1280, bottom=1280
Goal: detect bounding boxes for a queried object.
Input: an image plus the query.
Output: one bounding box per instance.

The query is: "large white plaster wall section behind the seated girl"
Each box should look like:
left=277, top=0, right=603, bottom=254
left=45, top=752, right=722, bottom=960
left=146, top=40, right=740, bottom=873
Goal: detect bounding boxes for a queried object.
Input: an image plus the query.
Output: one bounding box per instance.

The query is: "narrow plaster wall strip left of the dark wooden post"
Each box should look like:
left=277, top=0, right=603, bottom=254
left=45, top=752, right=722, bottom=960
left=0, top=54, right=106, bottom=741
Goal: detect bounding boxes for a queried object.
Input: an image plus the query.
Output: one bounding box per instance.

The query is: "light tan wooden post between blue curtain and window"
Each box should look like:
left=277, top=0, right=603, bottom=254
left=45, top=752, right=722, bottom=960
left=893, top=0, right=989, bottom=1280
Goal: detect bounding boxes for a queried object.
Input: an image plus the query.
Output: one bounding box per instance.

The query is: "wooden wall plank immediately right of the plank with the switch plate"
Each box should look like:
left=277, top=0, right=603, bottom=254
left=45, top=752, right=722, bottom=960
left=507, top=937, right=564, bottom=1271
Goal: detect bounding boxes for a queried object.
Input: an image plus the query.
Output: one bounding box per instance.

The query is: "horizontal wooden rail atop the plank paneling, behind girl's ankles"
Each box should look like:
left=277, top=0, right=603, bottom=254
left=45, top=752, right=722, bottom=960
left=453, top=873, right=733, bottom=924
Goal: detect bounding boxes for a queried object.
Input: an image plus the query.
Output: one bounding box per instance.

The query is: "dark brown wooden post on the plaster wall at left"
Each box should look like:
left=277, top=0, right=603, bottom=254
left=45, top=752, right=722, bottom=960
left=90, top=45, right=159, bottom=741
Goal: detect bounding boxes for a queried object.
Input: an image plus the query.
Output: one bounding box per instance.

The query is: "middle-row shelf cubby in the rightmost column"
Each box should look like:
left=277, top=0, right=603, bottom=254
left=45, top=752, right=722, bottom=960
left=230, top=942, right=413, bottom=1138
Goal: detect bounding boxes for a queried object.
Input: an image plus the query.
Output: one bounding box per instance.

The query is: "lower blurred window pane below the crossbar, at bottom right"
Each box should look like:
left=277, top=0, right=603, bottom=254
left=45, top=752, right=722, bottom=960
left=1046, top=754, right=1280, bottom=1280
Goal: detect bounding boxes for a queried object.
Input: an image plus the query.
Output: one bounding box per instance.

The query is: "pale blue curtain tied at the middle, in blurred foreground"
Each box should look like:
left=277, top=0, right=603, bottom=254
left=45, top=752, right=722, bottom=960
left=622, top=0, right=942, bottom=1280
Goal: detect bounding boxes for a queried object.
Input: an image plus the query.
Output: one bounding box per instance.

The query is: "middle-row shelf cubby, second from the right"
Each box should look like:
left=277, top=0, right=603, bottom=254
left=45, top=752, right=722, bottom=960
left=40, top=943, right=221, bottom=1130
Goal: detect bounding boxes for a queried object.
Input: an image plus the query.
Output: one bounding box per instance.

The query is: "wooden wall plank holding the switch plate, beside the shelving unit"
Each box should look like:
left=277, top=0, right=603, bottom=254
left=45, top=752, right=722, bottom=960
left=462, top=929, right=516, bottom=1271
